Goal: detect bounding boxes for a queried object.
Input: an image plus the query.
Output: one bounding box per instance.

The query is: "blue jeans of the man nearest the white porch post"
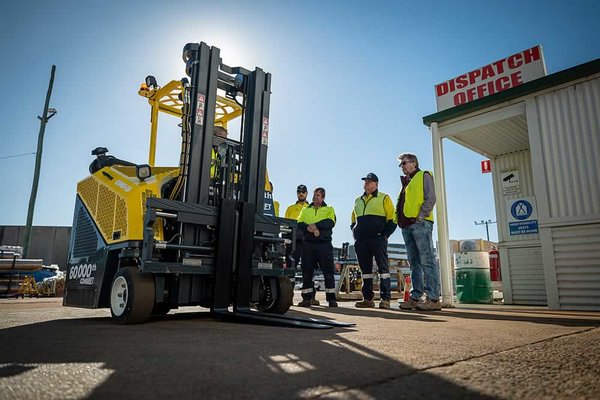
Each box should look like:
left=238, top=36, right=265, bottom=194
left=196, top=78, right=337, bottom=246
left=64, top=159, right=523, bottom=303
left=402, top=221, right=440, bottom=301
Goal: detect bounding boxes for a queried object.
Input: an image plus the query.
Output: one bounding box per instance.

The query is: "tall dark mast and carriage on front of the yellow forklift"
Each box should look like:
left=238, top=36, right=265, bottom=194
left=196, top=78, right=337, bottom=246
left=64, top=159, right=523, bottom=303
left=141, top=43, right=296, bottom=310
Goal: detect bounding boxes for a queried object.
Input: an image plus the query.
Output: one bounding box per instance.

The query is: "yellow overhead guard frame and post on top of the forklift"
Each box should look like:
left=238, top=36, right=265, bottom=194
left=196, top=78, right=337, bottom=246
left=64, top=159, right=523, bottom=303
left=138, top=81, right=242, bottom=167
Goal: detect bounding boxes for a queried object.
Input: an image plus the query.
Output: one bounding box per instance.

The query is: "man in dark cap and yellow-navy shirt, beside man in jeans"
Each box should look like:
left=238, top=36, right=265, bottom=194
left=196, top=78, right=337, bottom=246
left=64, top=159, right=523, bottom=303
left=350, top=172, right=396, bottom=309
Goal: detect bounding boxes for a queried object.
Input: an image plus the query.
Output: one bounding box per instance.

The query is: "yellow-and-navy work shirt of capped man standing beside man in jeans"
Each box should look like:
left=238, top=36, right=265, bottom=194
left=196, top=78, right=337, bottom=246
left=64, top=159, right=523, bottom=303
left=351, top=190, right=396, bottom=240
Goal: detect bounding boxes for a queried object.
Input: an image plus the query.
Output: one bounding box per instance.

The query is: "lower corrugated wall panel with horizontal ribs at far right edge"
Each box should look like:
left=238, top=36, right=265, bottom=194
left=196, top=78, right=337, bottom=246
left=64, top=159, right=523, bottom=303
left=552, top=224, right=600, bottom=310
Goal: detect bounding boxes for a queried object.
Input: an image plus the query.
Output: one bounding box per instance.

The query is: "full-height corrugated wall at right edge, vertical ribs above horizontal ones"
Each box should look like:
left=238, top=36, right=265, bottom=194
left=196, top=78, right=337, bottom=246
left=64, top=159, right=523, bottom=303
left=532, top=78, right=600, bottom=310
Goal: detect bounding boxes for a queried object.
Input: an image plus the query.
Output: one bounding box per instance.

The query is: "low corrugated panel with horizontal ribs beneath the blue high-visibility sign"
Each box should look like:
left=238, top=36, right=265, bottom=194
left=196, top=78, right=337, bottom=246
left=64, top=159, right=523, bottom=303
left=508, top=246, right=547, bottom=305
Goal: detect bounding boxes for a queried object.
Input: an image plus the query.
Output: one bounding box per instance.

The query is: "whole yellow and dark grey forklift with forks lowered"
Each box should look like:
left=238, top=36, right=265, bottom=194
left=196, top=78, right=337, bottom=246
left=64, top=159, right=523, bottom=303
left=63, top=43, right=351, bottom=329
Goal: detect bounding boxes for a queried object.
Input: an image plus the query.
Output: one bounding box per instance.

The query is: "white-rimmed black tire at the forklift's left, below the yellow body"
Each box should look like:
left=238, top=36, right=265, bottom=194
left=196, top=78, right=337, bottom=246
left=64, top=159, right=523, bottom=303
left=110, top=267, right=154, bottom=324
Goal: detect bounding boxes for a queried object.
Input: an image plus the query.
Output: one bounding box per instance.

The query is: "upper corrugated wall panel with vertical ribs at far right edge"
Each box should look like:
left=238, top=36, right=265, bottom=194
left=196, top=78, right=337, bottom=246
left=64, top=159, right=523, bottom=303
left=537, top=79, right=600, bottom=219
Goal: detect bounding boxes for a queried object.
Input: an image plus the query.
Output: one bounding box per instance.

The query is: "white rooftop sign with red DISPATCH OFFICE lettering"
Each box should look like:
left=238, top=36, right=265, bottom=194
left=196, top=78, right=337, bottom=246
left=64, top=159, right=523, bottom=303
left=435, top=46, right=546, bottom=111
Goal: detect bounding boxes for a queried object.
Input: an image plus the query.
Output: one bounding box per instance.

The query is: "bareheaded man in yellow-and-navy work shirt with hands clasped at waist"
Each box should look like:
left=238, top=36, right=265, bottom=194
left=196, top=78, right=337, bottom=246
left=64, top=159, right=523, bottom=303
left=298, top=187, right=337, bottom=307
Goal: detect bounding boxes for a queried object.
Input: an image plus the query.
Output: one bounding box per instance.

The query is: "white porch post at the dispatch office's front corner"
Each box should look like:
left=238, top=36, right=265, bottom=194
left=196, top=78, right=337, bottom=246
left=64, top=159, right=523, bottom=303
left=431, top=122, right=454, bottom=307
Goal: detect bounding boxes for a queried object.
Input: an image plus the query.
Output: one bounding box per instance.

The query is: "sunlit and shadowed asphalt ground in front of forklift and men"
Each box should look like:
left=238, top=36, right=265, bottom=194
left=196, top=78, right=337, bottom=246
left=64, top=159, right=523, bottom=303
left=0, top=293, right=600, bottom=400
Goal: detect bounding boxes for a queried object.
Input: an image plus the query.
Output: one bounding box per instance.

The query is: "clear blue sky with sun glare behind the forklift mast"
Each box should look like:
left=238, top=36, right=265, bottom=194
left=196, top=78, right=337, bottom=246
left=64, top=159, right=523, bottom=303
left=0, top=0, right=600, bottom=245
